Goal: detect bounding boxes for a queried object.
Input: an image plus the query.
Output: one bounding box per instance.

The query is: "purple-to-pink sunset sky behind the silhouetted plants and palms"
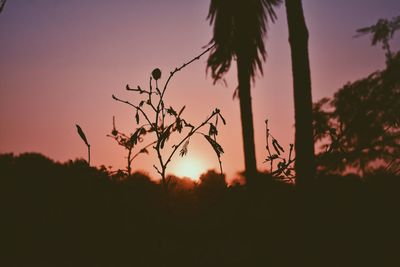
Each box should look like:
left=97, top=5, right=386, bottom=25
left=0, top=0, right=400, bottom=182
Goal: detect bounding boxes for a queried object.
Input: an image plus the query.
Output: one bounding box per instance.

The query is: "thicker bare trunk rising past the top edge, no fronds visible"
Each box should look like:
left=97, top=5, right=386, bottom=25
left=285, top=0, right=315, bottom=187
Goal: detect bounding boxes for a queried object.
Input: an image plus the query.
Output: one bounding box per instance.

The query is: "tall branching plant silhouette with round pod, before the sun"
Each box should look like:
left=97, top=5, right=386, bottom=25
left=112, top=47, right=225, bottom=195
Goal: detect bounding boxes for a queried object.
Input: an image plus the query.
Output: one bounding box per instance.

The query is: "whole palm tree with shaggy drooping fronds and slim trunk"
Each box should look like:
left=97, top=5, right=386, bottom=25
left=207, top=0, right=281, bottom=186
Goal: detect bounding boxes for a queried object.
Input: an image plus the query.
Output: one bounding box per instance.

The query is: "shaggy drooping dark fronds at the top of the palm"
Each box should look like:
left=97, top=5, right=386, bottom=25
left=207, top=0, right=282, bottom=81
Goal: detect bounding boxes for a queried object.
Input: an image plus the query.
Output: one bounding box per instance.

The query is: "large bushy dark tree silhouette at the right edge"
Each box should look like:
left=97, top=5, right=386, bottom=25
left=314, top=18, right=400, bottom=174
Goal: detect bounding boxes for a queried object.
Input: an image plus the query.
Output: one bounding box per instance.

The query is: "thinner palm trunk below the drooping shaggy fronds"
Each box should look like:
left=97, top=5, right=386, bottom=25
left=237, top=55, right=257, bottom=186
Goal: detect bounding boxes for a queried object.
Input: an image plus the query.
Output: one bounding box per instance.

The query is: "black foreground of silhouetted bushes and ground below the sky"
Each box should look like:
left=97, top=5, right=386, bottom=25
left=0, top=154, right=400, bottom=267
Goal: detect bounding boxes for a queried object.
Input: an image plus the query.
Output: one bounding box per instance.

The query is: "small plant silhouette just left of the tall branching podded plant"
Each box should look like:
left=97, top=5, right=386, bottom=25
left=107, top=117, right=156, bottom=175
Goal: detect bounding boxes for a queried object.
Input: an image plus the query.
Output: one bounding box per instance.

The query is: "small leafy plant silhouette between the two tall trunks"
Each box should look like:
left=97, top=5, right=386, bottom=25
left=264, top=120, right=295, bottom=182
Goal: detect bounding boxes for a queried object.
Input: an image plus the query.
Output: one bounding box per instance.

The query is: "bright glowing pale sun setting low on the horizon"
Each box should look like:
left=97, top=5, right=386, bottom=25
left=172, top=157, right=205, bottom=180
